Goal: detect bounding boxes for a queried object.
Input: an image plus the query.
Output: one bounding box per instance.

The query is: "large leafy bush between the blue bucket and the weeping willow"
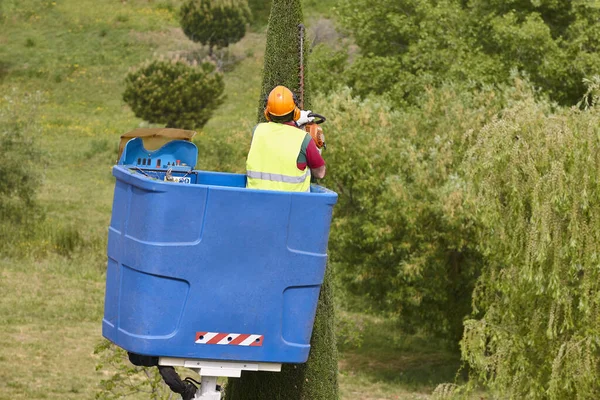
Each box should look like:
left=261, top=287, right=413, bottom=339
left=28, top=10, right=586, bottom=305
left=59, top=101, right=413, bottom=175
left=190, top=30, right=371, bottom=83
left=316, top=86, right=507, bottom=345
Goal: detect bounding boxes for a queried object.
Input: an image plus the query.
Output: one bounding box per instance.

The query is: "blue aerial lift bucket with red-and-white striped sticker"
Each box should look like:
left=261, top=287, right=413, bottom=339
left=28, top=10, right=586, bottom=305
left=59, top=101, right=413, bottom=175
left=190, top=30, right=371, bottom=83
left=102, top=140, right=337, bottom=363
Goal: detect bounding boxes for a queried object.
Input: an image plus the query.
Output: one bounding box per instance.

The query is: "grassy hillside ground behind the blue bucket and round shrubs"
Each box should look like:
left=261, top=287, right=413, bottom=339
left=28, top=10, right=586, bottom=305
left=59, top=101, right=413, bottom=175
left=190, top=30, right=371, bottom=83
left=0, top=0, right=466, bottom=400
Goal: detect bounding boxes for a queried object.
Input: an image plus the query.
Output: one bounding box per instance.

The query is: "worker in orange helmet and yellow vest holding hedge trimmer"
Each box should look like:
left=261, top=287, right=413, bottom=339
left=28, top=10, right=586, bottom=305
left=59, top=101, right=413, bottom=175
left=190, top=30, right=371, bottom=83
left=246, top=86, right=325, bottom=192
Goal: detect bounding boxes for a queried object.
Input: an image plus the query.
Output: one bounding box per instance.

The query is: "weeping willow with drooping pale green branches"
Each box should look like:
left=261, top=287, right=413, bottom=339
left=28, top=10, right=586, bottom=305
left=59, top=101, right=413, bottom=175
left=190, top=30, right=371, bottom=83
left=454, top=79, right=600, bottom=399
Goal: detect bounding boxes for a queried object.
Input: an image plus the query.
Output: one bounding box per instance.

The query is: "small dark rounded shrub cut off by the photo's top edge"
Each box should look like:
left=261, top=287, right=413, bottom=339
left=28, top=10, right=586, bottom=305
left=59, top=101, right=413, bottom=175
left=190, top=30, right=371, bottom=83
left=179, top=0, right=251, bottom=52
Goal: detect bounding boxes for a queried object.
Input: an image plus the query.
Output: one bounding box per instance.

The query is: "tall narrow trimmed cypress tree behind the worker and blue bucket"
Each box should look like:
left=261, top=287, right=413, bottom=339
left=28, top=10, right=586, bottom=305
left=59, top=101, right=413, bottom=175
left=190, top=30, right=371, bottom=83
left=225, top=0, right=339, bottom=400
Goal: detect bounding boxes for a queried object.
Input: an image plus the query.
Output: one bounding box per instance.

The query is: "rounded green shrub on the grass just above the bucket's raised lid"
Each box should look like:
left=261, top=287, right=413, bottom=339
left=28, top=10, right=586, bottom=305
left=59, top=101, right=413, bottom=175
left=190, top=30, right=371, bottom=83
left=123, top=59, right=225, bottom=129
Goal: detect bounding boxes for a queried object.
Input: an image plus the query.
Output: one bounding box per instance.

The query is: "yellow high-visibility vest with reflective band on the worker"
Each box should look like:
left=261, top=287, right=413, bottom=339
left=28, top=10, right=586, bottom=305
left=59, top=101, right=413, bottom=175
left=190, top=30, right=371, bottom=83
left=246, top=122, right=310, bottom=192
